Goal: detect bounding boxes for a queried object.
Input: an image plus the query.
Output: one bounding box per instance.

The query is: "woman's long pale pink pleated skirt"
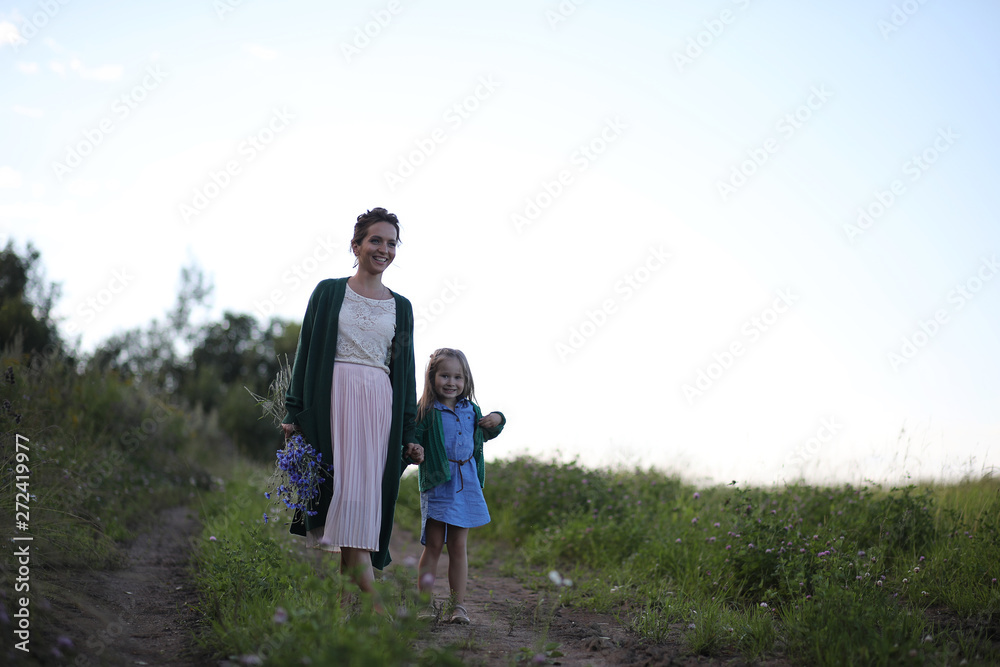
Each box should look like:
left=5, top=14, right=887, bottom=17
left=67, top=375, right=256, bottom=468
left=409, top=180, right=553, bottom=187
left=306, top=362, right=392, bottom=551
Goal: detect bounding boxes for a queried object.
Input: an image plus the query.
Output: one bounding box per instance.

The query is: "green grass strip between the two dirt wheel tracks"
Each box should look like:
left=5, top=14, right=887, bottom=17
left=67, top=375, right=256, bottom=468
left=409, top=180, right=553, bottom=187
left=194, top=464, right=462, bottom=666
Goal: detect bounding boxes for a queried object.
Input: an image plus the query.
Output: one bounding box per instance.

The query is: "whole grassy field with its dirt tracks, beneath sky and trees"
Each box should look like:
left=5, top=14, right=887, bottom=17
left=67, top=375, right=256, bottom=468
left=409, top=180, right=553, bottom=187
left=0, top=358, right=1000, bottom=665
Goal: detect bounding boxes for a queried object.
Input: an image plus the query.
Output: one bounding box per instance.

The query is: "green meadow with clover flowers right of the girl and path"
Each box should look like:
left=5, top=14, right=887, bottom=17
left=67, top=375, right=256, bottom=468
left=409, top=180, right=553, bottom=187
left=479, top=459, right=1000, bottom=665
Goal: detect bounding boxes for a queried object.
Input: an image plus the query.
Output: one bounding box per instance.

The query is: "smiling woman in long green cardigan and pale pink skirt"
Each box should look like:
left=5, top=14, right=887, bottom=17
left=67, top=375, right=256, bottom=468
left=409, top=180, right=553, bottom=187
left=282, top=208, right=423, bottom=608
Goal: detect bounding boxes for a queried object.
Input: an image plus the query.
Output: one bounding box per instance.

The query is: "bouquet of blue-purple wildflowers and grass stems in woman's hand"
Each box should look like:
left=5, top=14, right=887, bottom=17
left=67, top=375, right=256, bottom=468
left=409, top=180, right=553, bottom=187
left=247, top=357, right=330, bottom=523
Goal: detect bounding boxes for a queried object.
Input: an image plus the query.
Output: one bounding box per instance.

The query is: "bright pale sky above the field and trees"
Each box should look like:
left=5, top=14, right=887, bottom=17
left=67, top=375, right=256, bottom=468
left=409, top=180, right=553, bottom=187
left=0, top=0, right=1000, bottom=482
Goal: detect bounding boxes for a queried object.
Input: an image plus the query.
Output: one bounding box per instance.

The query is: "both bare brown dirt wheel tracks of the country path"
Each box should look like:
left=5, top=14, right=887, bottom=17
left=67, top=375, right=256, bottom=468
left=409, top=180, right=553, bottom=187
left=33, top=507, right=760, bottom=667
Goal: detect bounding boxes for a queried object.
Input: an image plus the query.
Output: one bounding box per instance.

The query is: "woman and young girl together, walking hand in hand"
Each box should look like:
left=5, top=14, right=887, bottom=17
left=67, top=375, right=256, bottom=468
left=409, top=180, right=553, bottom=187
left=282, top=208, right=506, bottom=623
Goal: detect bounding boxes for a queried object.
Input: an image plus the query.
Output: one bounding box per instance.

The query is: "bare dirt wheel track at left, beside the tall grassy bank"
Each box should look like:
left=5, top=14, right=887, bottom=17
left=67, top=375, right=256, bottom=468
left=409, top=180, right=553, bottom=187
left=33, top=507, right=215, bottom=667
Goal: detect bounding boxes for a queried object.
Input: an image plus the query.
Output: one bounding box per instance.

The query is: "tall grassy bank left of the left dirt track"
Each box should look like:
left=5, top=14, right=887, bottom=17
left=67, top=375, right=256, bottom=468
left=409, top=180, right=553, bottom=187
left=0, top=351, right=212, bottom=662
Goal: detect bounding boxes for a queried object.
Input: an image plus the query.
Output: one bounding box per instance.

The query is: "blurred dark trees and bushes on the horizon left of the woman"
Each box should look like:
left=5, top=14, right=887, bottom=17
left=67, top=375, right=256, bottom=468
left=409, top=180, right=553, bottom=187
left=0, top=240, right=300, bottom=459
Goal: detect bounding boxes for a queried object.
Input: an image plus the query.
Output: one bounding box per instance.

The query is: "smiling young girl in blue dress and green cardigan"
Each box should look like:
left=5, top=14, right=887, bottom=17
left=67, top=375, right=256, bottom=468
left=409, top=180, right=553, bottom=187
left=416, top=347, right=506, bottom=624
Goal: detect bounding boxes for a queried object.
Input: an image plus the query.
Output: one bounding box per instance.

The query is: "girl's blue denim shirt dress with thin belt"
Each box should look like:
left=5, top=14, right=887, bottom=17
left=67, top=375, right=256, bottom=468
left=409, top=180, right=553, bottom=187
left=420, top=399, right=490, bottom=544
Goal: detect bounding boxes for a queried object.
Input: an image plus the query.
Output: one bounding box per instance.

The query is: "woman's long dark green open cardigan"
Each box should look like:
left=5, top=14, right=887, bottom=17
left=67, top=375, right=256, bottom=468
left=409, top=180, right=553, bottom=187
left=283, top=278, right=417, bottom=569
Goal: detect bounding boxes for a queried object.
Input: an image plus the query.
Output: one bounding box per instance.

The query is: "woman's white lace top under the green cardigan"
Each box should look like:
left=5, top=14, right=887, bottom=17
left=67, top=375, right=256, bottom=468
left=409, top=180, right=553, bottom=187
left=336, top=285, right=396, bottom=373
